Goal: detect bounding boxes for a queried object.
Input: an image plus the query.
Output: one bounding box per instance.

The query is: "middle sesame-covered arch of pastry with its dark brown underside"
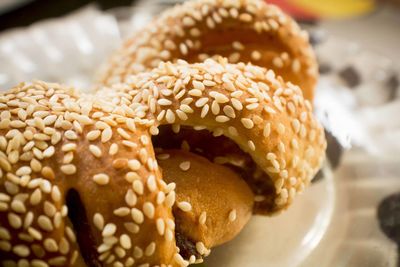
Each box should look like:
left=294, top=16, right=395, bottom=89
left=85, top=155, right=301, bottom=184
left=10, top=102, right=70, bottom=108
left=98, top=58, right=326, bottom=214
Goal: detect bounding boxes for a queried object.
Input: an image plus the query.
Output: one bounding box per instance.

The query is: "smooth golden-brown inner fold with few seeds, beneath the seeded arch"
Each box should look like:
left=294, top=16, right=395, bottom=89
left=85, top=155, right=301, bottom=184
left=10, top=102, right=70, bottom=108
left=158, top=150, right=254, bottom=249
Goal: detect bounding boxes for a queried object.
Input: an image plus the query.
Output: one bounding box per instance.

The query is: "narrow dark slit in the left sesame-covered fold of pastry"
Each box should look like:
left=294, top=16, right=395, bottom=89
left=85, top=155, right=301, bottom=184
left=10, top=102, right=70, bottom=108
left=66, top=189, right=103, bottom=267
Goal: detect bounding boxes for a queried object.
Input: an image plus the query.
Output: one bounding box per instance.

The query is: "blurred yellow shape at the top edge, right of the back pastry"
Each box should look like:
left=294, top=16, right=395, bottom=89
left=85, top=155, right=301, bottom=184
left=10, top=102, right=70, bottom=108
left=288, top=0, right=376, bottom=19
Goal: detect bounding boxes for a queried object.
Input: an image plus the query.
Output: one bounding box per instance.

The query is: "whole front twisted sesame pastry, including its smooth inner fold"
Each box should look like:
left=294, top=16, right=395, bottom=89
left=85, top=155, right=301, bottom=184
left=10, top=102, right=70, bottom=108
left=0, top=59, right=325, bottom=267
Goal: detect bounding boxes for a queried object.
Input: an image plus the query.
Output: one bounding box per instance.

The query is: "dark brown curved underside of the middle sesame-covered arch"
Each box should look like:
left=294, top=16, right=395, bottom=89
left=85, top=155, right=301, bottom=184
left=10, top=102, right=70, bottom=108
left=152, top=125, right=275, bottom=213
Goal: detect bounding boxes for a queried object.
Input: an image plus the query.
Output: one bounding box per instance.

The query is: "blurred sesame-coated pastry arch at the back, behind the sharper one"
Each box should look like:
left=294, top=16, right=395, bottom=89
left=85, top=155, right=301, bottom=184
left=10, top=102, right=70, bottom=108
left=99, top=0, right=318, bottom=100
